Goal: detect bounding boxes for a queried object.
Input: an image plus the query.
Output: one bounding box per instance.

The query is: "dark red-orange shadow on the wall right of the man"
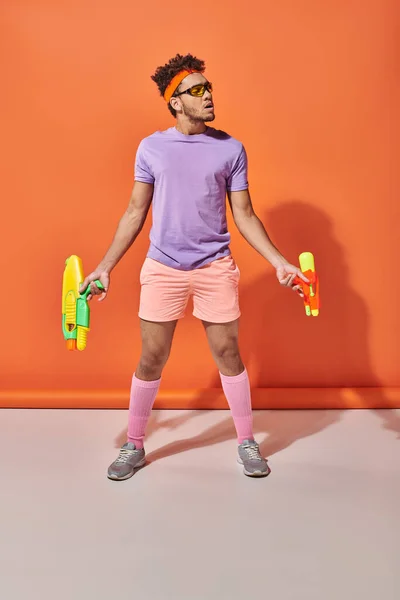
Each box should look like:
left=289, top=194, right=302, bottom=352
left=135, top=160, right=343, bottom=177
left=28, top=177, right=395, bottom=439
left=241, top=201, right=372, bottom=387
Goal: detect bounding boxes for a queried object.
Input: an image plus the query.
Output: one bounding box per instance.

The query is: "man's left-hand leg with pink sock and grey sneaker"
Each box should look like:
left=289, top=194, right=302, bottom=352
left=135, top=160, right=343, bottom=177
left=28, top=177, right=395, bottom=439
left=108, top=319, right=177, bottom=480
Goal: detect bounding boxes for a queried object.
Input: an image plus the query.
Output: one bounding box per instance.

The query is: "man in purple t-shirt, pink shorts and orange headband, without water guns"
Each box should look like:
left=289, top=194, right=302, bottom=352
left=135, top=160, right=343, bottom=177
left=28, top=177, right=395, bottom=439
left=81, top=54, right=307, bottom=480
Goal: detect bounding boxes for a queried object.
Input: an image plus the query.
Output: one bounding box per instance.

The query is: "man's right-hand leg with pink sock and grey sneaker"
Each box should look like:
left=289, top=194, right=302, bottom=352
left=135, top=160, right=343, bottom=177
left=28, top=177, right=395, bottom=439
left=203, top=320, right=270, bottom=477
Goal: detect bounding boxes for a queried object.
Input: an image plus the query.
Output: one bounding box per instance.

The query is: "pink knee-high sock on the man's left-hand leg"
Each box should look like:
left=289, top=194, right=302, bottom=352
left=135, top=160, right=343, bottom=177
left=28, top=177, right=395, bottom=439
left=128, top=375, right=161, bottom=449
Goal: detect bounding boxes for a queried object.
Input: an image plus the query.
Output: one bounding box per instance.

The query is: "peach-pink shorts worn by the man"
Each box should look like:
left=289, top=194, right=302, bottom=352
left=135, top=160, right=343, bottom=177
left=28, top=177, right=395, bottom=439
left=139, top=256, right=240, bottom=323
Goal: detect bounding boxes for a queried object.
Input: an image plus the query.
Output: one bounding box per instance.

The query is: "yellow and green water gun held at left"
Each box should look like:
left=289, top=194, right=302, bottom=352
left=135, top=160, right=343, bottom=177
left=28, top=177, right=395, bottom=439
left=62, top=254, right=104, bottom=350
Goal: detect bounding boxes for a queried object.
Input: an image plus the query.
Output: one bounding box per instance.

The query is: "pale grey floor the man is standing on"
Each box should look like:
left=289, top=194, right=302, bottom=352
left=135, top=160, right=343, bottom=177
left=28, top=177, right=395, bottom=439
left=0, top=410, right=400, bottom=600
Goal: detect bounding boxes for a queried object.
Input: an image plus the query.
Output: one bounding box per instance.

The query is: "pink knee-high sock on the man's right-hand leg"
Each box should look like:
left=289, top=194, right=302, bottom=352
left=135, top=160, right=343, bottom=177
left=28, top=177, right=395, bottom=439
left=220, top=369, right=254, bottom=444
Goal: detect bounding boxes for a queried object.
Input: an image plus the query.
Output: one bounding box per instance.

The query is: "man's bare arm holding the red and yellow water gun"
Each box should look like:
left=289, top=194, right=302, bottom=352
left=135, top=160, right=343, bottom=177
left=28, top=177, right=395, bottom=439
left=228, top=189, right=308, bottom=291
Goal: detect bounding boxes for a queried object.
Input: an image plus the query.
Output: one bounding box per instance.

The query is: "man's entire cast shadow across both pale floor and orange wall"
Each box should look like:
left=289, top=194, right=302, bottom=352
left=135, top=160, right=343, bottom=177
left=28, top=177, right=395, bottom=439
left=115, top=201, right=400, bottom=462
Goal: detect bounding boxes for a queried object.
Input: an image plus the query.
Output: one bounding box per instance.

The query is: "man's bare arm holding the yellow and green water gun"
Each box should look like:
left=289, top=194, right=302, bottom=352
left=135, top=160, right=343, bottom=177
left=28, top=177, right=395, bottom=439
left=80, top=181, right=154, bottom=300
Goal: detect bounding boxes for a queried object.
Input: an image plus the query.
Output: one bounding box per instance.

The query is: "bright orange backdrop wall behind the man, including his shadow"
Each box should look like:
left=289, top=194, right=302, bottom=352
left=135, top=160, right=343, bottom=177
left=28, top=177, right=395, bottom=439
left=0, top=0, right=400, bottom=405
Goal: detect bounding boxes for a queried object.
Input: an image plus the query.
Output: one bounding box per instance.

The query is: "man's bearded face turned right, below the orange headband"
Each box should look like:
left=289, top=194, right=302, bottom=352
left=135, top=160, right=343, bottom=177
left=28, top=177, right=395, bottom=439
left=173, top=73, right=215, bottom=123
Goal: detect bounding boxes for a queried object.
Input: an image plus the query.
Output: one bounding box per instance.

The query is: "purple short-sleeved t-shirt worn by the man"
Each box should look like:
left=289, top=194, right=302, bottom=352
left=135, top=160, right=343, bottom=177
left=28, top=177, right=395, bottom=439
left=135, top=127, right=248, bottom=271
